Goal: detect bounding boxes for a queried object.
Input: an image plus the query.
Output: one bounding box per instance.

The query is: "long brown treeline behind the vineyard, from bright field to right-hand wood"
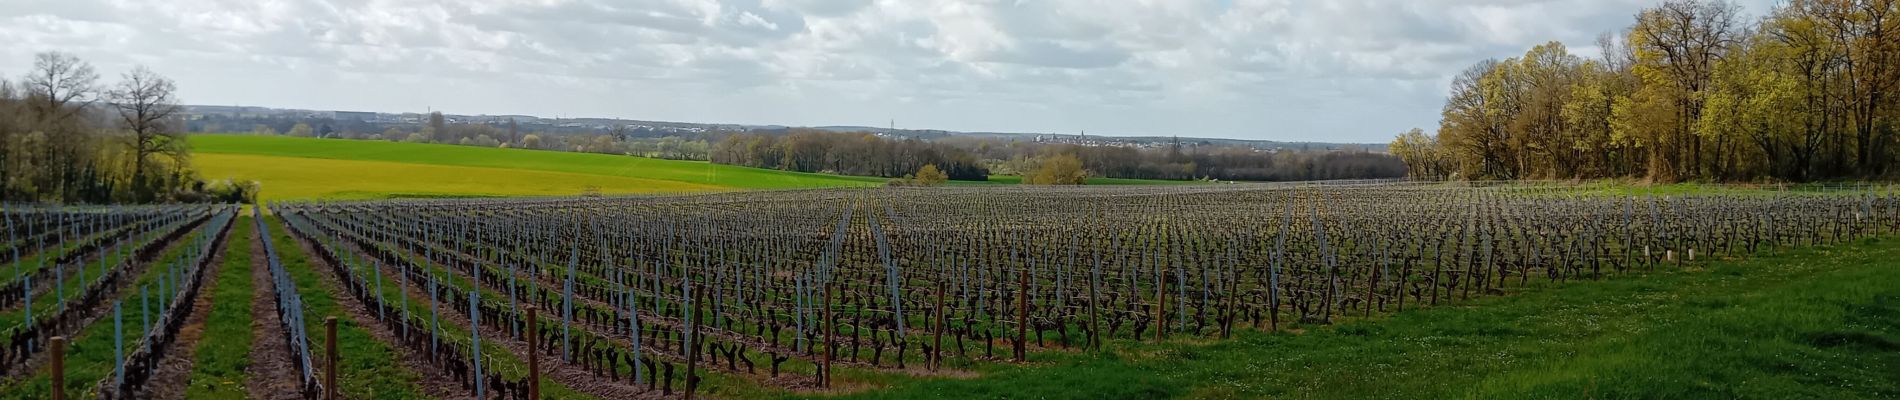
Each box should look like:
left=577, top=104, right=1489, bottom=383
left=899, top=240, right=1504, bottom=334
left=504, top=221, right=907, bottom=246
left=713, top=129, right=1406, bottom=182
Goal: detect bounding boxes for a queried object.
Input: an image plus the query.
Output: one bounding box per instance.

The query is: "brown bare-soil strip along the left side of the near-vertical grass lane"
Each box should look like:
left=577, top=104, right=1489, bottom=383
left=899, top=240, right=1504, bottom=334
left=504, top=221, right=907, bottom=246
left=144, top=218, right=238, bottom=400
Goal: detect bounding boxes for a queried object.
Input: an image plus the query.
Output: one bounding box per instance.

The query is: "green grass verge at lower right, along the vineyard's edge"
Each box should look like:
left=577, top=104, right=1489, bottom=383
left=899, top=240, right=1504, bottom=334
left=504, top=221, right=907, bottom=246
left=813, top=237, right=1900, bottom=398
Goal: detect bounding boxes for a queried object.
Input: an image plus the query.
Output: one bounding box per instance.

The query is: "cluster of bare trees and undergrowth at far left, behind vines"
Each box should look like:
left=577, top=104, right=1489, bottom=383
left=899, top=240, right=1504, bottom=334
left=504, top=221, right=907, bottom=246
left=0, top=53, right=257, bottom=203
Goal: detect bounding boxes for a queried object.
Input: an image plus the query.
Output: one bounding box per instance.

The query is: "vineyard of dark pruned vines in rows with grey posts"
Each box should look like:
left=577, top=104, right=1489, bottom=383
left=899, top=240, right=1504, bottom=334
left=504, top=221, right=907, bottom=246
left=0, top=182, right=1900, bottom=398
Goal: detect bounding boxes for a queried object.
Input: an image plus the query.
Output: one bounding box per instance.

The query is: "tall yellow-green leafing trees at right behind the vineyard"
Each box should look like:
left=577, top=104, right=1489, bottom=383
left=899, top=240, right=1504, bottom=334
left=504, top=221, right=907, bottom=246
left=1391, top=0, right=1900, bottom=182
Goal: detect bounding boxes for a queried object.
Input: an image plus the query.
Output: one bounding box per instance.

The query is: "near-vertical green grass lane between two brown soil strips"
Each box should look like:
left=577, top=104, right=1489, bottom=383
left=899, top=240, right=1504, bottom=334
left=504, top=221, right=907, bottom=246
left=184, top=216, right=257, bottom=398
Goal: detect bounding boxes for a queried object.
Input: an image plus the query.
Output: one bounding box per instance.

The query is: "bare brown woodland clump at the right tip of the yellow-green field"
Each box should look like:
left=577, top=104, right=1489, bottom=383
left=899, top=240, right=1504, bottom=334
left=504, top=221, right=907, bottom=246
left=711, top=129, right=990, bottom=180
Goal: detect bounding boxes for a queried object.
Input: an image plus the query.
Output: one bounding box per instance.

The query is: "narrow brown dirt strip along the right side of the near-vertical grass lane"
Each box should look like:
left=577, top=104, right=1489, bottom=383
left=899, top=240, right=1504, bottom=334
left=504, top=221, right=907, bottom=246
left=243, top=222, right=302, bottom=400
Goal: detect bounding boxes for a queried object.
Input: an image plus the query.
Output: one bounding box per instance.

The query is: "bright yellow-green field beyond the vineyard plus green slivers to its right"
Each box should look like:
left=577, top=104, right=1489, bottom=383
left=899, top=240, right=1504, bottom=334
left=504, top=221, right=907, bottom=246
left=190, top=135, right=1193, bottom=199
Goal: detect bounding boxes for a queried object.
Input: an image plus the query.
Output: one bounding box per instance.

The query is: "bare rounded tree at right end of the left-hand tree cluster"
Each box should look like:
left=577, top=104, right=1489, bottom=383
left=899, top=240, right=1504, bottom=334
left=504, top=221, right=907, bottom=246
left=108, top=66, right=184, bottom=201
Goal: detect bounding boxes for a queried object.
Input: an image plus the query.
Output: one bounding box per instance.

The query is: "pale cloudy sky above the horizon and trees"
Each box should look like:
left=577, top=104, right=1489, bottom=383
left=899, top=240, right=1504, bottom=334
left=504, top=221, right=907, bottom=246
left=0, top=0, right=1775, bottom=142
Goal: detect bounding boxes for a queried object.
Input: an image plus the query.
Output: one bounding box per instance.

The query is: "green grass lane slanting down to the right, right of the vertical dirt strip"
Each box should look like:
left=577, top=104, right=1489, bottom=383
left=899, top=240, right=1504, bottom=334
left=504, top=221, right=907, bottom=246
left=266, top=218, right=428, bottom=398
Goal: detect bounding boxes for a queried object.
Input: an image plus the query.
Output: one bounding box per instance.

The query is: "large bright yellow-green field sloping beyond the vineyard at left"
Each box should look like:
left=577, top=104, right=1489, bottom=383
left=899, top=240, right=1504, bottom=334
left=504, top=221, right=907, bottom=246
left=190, top=135, right=884, bottom=195
